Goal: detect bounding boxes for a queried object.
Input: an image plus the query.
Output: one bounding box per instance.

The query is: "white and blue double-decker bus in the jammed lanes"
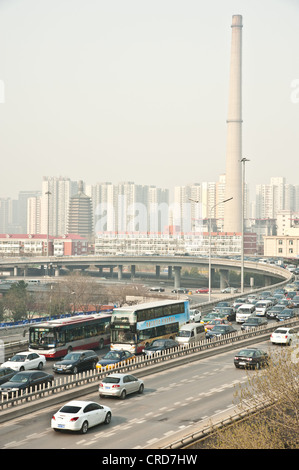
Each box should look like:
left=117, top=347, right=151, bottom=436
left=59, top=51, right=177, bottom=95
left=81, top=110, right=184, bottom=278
left=110, top=300, right=190, bottom=354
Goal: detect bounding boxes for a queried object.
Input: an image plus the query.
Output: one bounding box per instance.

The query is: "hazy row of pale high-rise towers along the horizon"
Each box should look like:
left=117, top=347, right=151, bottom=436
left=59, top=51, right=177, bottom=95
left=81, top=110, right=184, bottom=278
left=0, top=175, right=299, bottom=239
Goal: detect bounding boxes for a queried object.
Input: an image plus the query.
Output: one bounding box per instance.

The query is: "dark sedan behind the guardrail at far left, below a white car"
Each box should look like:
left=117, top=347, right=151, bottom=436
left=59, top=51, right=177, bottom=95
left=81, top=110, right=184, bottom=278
left=0, top=370, right=54, bottom=398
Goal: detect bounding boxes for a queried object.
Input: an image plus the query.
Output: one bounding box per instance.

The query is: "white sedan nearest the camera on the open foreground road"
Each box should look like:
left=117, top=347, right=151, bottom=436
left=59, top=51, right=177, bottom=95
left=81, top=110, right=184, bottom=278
left=51, top=400, right=112, bottom=434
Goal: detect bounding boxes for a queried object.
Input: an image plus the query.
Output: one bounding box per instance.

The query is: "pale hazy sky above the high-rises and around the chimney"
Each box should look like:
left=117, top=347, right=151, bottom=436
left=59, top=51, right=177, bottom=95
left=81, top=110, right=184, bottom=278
left=0, top=0, right=299, bottom=198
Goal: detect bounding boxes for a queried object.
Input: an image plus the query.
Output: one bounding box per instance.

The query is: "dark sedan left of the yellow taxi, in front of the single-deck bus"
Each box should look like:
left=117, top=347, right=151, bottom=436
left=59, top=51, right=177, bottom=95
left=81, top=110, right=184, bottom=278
left=53, top=350, right=99, bottom=374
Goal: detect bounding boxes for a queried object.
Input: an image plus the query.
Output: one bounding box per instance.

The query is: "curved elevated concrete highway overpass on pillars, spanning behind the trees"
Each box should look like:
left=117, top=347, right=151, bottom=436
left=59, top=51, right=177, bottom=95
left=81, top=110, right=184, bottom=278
left=0, top=255, right=292, bottom=288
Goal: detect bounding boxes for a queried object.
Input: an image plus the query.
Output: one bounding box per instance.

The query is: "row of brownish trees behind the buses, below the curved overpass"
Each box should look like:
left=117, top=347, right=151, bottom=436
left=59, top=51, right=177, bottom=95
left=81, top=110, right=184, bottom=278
left=0, top=271, right=150, bottom=321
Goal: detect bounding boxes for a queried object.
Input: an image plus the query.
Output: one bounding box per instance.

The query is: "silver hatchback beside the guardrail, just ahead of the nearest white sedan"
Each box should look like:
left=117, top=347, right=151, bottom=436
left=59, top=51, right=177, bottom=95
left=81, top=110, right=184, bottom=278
left=99, top=374, right=144, bottom=400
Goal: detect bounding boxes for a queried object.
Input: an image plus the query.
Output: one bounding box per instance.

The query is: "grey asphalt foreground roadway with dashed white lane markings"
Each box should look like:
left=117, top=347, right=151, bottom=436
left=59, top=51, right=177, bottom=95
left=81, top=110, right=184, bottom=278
left=1, top=343, right=269, bottom=449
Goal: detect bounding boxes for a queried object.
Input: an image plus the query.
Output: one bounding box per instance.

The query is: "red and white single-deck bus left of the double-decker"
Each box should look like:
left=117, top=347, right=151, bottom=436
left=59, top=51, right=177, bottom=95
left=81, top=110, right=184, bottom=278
left=29, top=313, right=111, bottom=359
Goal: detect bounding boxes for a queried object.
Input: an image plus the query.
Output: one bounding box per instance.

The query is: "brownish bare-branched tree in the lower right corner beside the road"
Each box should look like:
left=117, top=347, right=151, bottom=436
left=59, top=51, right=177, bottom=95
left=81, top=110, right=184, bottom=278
left=208, top=345, right=299, bottom=449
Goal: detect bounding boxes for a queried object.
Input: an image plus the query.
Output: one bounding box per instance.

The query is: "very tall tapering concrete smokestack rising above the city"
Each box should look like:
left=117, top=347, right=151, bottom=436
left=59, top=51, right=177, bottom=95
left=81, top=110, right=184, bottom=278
left=224, top=15, right=243, bottom=232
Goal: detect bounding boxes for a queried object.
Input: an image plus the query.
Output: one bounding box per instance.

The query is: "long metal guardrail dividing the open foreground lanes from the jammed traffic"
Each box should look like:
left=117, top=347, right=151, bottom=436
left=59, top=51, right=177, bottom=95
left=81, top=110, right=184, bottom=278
left=0, top=319, right=299, bottom=418
